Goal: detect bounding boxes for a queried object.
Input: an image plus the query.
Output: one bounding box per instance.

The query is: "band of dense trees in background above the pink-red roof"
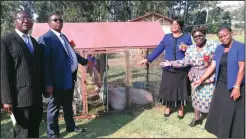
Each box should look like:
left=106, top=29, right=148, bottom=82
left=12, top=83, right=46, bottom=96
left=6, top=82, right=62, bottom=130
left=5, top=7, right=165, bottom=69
left=1, top=0, right=240, bottom=34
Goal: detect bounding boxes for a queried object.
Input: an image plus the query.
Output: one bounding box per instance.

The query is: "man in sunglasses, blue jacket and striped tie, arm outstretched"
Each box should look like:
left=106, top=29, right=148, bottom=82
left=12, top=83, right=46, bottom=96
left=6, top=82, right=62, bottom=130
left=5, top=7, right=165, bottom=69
left=38, top=13, right=92, bottom=138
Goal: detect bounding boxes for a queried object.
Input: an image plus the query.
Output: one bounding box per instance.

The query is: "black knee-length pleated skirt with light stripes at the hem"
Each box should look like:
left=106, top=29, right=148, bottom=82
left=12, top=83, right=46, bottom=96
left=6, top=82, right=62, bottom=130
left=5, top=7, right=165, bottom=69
left=159, top=69, right=189, bottom=107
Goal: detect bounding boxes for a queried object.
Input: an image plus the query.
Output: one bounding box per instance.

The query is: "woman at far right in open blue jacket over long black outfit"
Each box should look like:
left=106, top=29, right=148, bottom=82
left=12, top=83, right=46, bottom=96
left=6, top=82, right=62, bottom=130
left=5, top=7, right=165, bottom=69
left=194, top=27, right=245, bottom=138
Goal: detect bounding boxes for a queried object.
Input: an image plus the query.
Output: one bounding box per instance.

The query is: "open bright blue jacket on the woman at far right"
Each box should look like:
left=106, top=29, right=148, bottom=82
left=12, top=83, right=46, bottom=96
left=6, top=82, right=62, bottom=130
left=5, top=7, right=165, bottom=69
left=213, top=40, right=245, bottom=90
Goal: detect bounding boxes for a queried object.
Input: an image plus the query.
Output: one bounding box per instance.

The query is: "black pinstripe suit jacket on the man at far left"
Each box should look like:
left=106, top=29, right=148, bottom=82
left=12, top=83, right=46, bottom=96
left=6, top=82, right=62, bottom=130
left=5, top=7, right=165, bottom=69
left=1, top=32, right=44, bottom=107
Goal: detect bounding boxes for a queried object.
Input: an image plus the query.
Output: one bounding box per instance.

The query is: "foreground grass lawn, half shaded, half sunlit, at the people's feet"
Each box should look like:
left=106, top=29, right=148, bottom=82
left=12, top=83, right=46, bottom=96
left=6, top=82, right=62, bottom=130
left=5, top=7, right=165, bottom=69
left=1, top=105, right=215, bottom=138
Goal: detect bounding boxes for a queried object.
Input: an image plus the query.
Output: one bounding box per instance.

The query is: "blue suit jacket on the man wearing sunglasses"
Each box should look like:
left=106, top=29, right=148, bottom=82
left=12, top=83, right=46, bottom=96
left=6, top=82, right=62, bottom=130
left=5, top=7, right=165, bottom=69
left=38, top=30, right=88, bottom=90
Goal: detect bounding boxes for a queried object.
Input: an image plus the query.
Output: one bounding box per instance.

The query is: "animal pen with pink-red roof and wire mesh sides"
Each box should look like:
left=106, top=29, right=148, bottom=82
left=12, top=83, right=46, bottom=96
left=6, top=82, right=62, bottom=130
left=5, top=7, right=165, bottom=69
left=32, top=22, right=164, bottom=118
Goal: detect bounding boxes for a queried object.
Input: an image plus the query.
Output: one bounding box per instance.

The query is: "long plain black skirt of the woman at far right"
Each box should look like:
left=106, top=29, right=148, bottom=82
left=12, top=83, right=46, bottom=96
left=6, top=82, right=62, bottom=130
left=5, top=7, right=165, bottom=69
left=205, top=81, right=245, bottom=138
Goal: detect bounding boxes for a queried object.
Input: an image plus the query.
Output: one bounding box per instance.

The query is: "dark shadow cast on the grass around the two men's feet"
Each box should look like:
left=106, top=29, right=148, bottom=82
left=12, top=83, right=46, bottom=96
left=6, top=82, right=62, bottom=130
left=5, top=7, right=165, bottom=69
left=1, top=108, right=142, bottom=138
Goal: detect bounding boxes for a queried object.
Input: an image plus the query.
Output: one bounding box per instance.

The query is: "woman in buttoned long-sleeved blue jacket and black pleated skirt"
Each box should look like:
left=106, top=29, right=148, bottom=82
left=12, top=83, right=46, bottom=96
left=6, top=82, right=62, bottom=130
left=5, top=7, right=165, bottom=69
left=137, top=16, right=192, bottom=119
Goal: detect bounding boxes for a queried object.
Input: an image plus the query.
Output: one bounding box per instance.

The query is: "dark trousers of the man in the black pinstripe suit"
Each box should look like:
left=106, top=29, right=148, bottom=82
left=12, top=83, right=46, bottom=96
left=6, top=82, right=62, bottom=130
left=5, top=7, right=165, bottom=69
left=13, top=106, right=43, bottom=138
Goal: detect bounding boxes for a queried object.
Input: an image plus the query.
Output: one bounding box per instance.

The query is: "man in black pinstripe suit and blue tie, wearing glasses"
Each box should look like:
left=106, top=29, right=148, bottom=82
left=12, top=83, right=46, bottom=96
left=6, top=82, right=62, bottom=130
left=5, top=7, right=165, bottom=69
left=1, top=11, right=44, bottom=138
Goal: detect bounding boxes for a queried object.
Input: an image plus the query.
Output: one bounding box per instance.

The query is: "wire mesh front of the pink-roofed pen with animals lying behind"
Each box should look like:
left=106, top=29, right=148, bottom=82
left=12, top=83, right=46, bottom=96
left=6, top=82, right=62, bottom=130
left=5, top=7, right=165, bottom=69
left=44, top=48, right=163, bottom=115
